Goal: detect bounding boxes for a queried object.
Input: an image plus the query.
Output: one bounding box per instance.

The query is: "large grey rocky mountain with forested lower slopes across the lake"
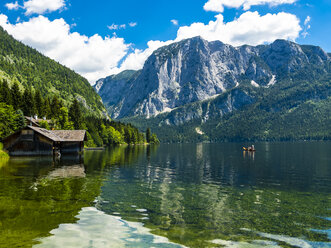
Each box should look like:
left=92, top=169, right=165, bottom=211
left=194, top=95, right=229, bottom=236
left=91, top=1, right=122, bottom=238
left=97, top=37, right=331, bottom=142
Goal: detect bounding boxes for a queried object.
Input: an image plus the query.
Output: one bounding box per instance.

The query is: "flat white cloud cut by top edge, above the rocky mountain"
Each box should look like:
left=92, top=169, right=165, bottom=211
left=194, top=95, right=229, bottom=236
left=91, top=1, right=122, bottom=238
left=203, top=0, right=297, bottom=13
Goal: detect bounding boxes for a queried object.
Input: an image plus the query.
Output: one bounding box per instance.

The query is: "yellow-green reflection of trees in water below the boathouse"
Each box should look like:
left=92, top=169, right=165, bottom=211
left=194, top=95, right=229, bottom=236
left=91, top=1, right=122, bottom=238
left=0, top=157, right=102, bottom=247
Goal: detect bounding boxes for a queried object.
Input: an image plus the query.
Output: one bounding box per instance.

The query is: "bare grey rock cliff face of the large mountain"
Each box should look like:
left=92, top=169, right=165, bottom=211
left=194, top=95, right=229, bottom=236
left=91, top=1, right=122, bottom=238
left=95, top=37, right=330, bottom=120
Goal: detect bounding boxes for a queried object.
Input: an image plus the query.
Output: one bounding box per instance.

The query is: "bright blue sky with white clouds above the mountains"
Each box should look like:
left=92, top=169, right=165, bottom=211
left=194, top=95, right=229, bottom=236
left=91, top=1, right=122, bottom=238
left=0, top=0, right=331, bottom=85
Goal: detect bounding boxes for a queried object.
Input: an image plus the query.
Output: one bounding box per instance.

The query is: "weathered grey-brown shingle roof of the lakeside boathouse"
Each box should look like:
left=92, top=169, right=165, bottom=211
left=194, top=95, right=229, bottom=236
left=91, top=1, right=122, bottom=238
left=28, top=126, right=86, bottom=142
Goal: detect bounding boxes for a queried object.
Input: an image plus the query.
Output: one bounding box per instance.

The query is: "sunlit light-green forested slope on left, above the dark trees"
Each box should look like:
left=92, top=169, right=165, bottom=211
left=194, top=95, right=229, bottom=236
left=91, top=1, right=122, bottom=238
left=0, top=27, right=107, bottom=117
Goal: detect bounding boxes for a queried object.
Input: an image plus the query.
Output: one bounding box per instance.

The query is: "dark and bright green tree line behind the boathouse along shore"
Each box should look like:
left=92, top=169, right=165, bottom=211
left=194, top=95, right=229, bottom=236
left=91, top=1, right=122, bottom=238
left=0, top=80, right=159, bottom=147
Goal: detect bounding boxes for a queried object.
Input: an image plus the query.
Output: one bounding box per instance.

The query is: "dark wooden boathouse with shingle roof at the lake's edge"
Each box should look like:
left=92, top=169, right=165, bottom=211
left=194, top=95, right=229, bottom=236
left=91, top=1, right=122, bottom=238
left=3, top=125, right=87, bottom=156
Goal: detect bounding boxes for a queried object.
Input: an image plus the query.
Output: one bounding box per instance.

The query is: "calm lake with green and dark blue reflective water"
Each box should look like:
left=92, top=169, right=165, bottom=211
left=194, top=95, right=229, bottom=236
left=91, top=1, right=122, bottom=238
left=0, top=142, right=331, bottom=248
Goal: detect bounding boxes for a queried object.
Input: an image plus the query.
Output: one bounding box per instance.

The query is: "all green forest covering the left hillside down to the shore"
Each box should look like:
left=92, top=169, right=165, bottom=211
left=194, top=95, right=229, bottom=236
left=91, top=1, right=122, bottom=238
left=0, top=27, right=155, bottom=147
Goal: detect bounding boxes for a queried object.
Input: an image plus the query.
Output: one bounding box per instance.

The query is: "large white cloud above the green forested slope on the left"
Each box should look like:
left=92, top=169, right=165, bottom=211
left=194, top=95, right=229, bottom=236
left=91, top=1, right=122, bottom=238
left=0, top=14, right=129, bottom=83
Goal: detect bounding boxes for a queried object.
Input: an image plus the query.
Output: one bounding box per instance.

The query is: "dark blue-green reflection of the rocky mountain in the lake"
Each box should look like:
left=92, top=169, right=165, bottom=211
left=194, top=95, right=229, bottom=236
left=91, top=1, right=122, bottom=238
left=101, top=143, right=331, bottom=247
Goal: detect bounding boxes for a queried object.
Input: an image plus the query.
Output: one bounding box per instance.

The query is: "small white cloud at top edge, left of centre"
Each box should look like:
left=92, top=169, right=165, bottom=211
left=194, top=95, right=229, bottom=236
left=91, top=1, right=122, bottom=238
left=23, top=0, right=65, bottom=15
